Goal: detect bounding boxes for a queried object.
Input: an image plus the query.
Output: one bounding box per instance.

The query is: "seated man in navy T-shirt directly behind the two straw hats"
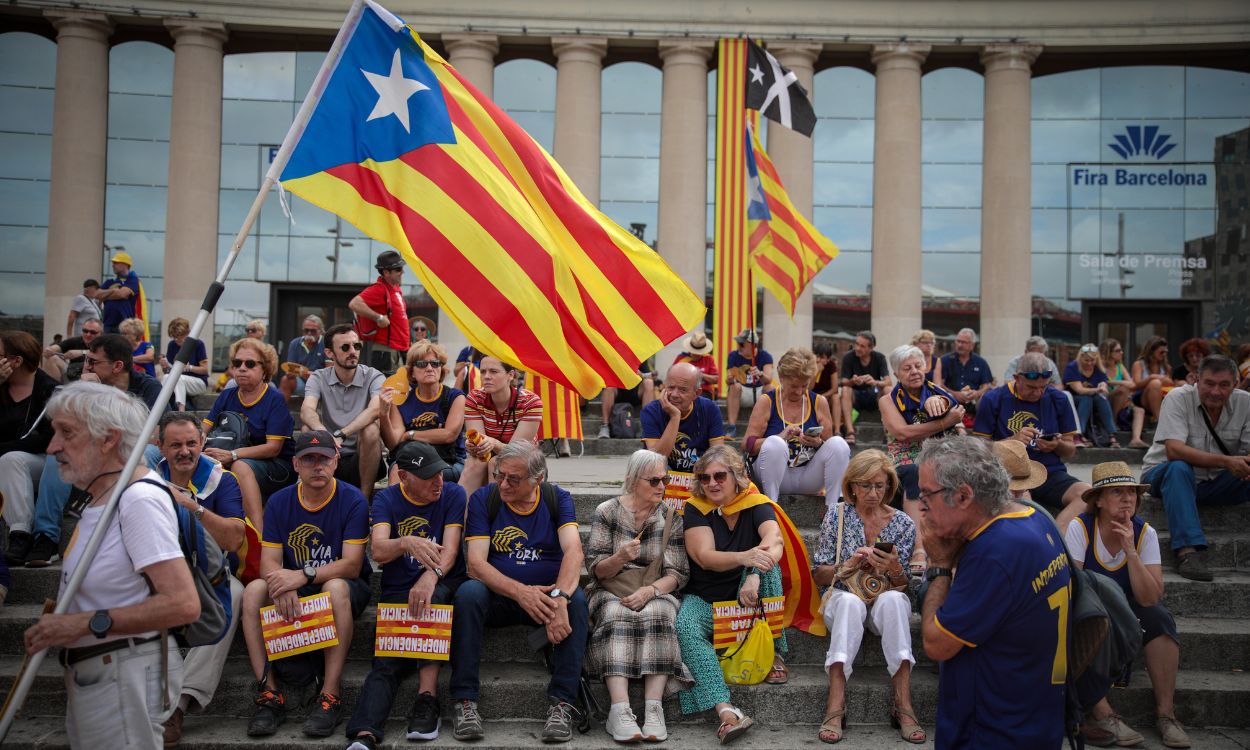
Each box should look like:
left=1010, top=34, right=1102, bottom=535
left=973, top=353, right=1090, bottom=529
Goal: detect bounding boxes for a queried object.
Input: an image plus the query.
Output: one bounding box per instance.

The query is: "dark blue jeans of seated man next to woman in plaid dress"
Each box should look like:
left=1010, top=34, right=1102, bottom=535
left=450, top=580, right=590, bottom=704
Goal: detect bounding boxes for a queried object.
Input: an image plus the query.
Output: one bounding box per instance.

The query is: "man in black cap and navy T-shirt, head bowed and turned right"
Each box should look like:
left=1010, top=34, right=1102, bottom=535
left=348, top=440, right=465, bottom=746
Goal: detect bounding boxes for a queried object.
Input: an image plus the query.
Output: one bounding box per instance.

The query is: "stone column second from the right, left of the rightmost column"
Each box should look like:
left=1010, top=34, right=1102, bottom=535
left=873, top=43, right=929, bottom=353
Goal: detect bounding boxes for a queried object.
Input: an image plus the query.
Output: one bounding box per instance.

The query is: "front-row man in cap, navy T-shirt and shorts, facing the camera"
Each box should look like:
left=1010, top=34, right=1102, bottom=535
left=243, top=430, right=373, bottom=738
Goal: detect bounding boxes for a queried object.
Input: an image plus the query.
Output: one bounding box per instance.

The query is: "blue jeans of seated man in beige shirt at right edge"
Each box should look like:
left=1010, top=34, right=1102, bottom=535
left=1141, top=461, right=1250, bottom=550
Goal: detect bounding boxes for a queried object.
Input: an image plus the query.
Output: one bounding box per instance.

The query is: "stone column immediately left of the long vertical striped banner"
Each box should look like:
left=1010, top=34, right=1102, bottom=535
left=655, top=39, right=715, bottom=376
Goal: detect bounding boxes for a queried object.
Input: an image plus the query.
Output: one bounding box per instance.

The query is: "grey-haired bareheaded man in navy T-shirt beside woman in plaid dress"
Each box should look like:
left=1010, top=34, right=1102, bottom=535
left=450, top=443, right=589, bottom=743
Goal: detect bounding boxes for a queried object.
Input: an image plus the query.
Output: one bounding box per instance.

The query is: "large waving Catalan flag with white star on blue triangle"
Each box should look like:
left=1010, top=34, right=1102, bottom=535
left=274, top=0, right=704, bottom=398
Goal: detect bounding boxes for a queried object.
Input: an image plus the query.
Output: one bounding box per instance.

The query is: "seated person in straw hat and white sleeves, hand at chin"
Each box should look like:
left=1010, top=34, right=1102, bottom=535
left=1065, top=461, right=1190, bottom=748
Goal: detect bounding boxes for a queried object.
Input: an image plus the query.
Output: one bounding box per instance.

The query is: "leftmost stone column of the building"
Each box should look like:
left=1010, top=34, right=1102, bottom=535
left=43, top=10, right=113, bottom=343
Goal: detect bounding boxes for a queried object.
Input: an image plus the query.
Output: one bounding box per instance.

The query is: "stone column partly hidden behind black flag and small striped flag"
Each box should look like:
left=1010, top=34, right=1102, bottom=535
left=764, top=41, right=821, bottom=360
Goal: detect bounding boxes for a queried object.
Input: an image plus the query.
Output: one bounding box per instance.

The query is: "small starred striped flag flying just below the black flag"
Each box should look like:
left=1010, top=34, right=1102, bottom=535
left=746, top=128, right=838, bottom=318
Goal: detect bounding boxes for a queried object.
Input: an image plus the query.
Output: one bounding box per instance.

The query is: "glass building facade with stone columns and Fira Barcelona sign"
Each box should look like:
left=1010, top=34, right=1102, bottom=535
left=0, top=0, right=1250, bottom=368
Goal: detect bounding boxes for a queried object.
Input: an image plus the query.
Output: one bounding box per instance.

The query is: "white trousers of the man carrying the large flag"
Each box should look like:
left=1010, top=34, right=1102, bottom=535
left=65, top=639, right=183, bottom=750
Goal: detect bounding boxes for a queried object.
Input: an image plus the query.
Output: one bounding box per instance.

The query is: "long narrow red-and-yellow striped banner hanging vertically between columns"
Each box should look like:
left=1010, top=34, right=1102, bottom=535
left=711, top=39, right=755, bottom=394
